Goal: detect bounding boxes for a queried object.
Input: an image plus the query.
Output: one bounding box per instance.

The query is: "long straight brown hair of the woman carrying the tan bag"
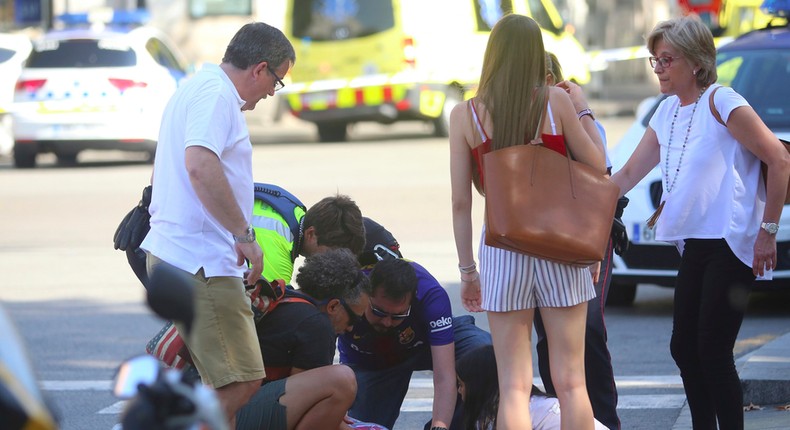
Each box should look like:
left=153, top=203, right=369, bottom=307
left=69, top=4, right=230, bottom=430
left=477, top=14, right=548, bottom=150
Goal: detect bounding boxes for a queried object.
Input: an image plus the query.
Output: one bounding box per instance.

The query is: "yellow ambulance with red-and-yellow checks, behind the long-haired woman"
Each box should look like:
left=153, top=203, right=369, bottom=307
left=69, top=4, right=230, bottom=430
left=282, top=0, right=590, bottom=142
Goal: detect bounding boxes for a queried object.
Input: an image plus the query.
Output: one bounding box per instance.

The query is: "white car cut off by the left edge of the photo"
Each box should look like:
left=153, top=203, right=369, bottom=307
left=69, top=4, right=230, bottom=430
left=0, top=33, right=32, bottom=156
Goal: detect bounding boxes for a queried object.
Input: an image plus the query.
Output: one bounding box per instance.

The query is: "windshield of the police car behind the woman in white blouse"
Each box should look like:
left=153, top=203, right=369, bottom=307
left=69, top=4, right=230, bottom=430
left=716, top=49, right=790, bottom=130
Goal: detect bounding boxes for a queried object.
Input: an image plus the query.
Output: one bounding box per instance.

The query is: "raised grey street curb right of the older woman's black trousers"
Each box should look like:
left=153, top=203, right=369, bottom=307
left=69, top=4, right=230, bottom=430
left=739, top=333, right=790, bottom=405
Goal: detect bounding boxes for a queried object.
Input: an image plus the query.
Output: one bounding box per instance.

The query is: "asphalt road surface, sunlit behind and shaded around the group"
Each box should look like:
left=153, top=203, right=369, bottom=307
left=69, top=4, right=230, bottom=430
left=0, top=118, right=790, bottom=430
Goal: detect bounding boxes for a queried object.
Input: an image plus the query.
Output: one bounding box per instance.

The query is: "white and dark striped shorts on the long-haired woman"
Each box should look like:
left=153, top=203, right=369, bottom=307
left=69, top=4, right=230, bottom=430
left=478, top=226, right=595, bottom=312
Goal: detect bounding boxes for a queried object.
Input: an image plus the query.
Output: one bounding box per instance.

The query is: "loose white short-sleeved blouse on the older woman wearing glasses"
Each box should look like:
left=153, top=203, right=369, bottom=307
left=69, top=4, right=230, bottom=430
left=650, top=85, right=770, bottom=272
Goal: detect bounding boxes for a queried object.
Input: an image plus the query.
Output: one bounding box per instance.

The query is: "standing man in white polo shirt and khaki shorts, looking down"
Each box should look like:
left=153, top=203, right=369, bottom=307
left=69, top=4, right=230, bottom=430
left=140, top=22, right=295, bottom=428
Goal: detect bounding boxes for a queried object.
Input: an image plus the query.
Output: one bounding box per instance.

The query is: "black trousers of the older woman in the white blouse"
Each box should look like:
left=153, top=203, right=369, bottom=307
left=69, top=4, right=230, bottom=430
left=670, top=239, right=754, bottom=430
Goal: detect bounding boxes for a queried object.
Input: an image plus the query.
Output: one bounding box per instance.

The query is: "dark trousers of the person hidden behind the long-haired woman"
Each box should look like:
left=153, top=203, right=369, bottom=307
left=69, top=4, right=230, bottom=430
left=535, top=239, right=620, bottom=430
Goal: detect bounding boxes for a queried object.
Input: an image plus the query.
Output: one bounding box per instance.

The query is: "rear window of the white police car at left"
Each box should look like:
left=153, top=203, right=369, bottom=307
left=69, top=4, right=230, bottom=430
left=27, top=39, right=137, bottom=68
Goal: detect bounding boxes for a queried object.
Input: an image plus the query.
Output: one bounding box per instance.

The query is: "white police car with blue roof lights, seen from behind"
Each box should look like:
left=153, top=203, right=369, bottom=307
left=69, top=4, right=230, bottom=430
left=12, top=12, right=187, bottom=167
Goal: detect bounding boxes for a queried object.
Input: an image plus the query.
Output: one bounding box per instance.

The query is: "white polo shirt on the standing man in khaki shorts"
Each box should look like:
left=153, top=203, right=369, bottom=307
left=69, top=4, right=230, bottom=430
left=140, top=64, right=254, bottom=277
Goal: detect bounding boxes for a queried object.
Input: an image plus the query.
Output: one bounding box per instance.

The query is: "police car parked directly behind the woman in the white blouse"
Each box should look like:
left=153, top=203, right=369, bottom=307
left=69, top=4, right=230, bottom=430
left=607, top=5, right=790, bottom=305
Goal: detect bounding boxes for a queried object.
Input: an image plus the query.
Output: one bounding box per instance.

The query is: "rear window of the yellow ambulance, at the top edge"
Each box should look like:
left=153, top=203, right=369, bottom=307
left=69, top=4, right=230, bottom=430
left=293, top=0, right=395, bottom=41
